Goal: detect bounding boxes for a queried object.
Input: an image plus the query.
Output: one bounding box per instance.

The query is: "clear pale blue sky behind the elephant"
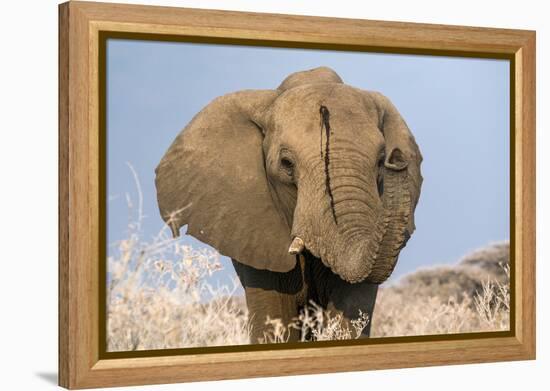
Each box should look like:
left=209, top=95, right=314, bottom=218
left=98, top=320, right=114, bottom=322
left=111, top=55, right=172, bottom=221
left=107, top=39, right=510, bottom=286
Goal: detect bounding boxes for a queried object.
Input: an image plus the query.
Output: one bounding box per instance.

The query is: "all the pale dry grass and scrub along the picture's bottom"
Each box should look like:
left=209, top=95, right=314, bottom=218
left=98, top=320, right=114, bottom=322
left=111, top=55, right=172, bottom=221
left=107, top=167, right=510, bottom=351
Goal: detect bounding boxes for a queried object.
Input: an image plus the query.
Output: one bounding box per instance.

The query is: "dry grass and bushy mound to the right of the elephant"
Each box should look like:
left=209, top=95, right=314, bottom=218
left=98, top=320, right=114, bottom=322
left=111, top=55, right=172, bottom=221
left=371, top=247, right=510, bottom=337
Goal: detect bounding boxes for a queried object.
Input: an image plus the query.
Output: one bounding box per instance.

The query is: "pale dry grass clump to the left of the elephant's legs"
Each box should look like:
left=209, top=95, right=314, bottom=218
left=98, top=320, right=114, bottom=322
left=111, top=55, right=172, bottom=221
left=107, top=230, right=248, bottom=351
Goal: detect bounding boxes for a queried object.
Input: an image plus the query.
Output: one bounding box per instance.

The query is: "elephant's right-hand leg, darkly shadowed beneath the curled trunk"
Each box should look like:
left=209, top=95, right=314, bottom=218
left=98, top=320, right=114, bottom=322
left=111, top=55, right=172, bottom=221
left=327, top=278, right=378, bottom=338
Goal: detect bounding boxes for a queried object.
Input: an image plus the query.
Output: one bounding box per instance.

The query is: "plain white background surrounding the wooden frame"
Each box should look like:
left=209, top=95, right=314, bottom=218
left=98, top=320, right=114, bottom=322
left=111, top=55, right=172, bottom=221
left=0, top=0, right=550, bottom=391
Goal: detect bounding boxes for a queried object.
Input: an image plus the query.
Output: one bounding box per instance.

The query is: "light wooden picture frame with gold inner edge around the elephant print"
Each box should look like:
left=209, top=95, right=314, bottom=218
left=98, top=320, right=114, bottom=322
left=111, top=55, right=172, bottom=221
left=59, top=1, right=535, bottom=389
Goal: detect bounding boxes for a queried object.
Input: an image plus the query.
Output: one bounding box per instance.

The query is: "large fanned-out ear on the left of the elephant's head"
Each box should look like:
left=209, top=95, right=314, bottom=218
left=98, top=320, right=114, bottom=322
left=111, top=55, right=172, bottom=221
left=155, top=90, right=296, bottom=272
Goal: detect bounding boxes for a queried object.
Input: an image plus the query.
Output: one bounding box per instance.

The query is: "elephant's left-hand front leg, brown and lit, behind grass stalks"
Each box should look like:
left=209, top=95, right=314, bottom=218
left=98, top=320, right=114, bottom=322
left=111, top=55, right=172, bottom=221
left=245, top=287, right=300, bottom=343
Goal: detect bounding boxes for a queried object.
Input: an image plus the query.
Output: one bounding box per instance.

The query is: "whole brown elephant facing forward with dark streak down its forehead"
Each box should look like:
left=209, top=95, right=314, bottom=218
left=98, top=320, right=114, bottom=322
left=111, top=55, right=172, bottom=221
left=155, top=67, right=423, bottom=343
